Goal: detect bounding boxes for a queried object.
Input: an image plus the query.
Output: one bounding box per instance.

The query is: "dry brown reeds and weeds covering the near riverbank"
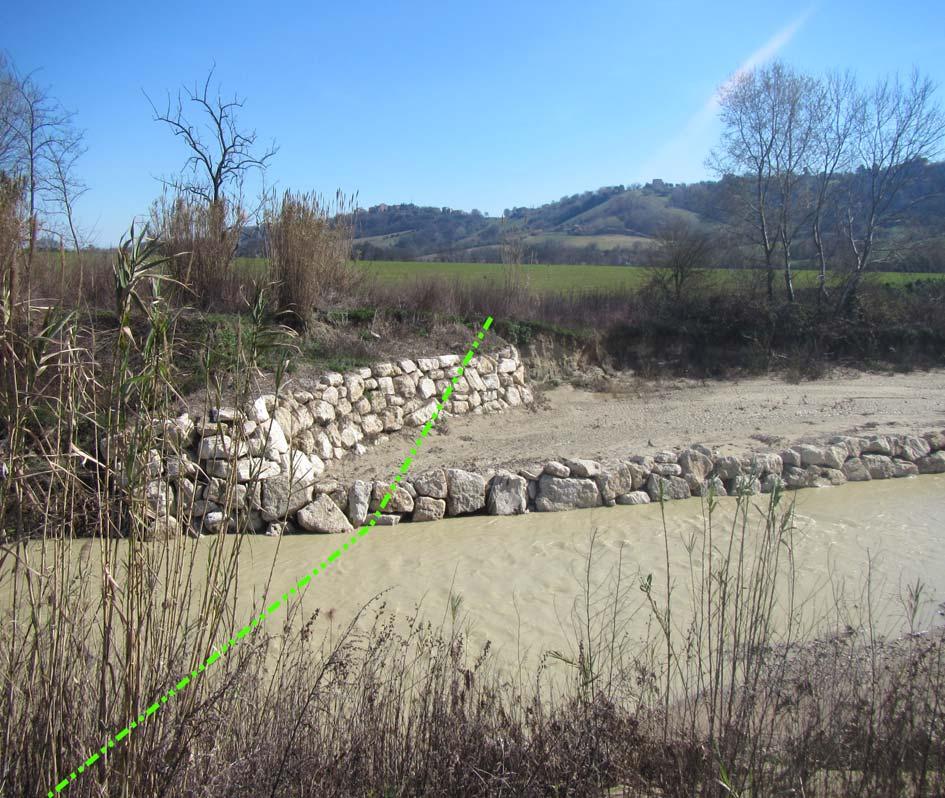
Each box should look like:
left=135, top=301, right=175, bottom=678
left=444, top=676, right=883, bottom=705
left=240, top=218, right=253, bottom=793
left=0, top=468, right=945, bottom=798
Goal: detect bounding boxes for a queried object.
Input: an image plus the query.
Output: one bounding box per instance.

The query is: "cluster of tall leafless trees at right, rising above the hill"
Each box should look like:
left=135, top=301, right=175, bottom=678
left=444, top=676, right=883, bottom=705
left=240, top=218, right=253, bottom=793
left=710, top=62, right=945, bottom=306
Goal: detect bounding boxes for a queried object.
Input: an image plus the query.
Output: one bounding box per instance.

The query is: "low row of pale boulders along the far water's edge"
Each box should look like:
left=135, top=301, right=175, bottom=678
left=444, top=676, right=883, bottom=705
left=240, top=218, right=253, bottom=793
left=290, top=431, right=945, bottom=532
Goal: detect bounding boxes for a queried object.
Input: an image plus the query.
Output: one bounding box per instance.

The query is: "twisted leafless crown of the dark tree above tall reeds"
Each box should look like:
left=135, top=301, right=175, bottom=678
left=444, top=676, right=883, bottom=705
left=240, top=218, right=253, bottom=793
left=145, top=69, right=277, bottom=205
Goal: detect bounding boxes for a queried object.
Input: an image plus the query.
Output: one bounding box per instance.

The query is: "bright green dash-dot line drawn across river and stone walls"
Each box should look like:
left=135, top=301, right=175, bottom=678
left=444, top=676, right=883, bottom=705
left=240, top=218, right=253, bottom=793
left=47, top=316, right=493, bottom=798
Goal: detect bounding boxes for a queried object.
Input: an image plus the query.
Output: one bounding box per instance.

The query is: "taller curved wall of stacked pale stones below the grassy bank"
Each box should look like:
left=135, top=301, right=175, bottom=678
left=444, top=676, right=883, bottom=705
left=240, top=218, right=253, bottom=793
left=140, top=346, right=533, bottom=537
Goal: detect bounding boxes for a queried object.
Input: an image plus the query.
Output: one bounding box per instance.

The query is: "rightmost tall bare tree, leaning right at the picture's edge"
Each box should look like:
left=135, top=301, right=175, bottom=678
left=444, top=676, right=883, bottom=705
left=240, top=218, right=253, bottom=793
left=837, top=70, right=945, bottom=309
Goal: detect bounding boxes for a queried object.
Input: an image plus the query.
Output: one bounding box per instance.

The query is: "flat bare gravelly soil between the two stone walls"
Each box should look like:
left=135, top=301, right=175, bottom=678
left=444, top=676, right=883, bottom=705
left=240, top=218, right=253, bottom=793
left=331, top=369, right=945, bottom=478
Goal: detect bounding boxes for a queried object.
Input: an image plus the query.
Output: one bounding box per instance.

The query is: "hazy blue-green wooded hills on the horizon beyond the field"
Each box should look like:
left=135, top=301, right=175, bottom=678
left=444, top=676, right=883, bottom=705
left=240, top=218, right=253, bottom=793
left=241, top=162, right=945, bottom=271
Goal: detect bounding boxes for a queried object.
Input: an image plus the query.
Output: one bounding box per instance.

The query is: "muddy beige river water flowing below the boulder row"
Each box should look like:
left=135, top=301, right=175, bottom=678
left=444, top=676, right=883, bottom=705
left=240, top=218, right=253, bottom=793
left=0, top=475, right=945, bottom=664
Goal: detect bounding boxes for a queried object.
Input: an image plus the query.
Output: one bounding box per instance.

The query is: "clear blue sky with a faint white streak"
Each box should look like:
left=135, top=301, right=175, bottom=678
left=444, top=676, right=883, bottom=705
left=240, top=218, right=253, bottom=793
left=0, top=0, right=945, bottom=244
